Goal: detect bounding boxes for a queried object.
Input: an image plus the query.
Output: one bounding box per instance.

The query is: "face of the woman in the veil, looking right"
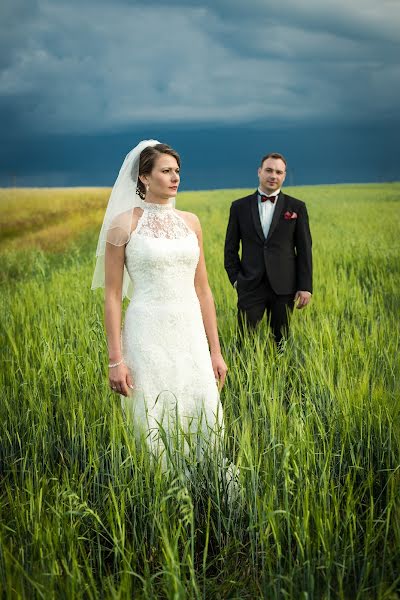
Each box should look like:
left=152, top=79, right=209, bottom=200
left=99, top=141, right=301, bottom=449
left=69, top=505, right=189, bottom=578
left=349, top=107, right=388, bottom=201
left=144, top=154, right=180, bottom=200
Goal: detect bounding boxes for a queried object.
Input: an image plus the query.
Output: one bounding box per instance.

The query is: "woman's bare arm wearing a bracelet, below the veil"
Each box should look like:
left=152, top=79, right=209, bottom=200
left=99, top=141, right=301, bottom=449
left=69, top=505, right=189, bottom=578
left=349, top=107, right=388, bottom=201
left=104, top=243, right=133, bottom=396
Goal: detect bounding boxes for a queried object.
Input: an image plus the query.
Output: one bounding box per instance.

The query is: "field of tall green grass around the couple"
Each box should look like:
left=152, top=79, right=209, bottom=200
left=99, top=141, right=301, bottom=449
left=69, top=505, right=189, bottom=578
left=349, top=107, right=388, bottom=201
left=0, top=184, right=400, bottom=600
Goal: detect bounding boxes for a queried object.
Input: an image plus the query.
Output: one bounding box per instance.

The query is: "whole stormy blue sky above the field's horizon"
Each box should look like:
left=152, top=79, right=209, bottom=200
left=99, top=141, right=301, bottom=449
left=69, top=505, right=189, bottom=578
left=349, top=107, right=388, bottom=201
left=0, top=0, right=400, bottom=189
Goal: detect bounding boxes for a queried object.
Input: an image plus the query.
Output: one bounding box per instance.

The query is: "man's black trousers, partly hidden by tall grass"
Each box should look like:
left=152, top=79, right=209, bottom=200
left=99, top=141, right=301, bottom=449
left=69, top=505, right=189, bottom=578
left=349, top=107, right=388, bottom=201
left=238, top=284, right=294, bottom=345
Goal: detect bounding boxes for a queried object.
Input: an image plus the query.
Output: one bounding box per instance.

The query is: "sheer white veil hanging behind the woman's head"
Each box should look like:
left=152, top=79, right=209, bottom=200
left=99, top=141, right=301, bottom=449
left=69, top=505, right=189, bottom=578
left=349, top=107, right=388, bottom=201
left=92, top=140, right=160, bottom=297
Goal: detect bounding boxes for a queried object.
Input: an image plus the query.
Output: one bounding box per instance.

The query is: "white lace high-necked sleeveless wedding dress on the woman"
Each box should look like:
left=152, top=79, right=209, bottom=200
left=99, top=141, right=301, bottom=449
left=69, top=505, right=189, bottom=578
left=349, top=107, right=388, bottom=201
left=121, top=202, right=223, bottom=460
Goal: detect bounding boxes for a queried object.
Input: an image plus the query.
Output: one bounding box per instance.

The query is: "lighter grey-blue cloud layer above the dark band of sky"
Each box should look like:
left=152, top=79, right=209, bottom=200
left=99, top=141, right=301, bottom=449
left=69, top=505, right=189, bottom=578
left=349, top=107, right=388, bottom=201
left=0, top=0, right=400, bottom=135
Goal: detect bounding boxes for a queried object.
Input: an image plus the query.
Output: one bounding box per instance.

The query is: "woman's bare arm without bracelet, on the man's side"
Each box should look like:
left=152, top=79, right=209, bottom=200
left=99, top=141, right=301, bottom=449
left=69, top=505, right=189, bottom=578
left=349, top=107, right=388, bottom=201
left=187, top=214, right=228, bottom=387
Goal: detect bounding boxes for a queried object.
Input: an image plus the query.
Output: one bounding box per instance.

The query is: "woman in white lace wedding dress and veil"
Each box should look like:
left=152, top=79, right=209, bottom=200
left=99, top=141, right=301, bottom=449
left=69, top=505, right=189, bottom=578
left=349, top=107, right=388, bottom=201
left=92, top=140, right=227, bottom=460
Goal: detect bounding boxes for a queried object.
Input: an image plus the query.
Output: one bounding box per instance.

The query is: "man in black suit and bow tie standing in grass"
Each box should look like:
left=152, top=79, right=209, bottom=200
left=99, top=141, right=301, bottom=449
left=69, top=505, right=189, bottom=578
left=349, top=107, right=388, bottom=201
left=225, top=153, right=312, bottom=345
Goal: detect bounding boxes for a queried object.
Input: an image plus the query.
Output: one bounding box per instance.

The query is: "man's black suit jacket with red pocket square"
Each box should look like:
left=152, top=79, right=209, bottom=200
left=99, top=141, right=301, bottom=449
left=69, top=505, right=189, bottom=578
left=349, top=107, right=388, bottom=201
left=225, top=191, right=312, bottom=308
